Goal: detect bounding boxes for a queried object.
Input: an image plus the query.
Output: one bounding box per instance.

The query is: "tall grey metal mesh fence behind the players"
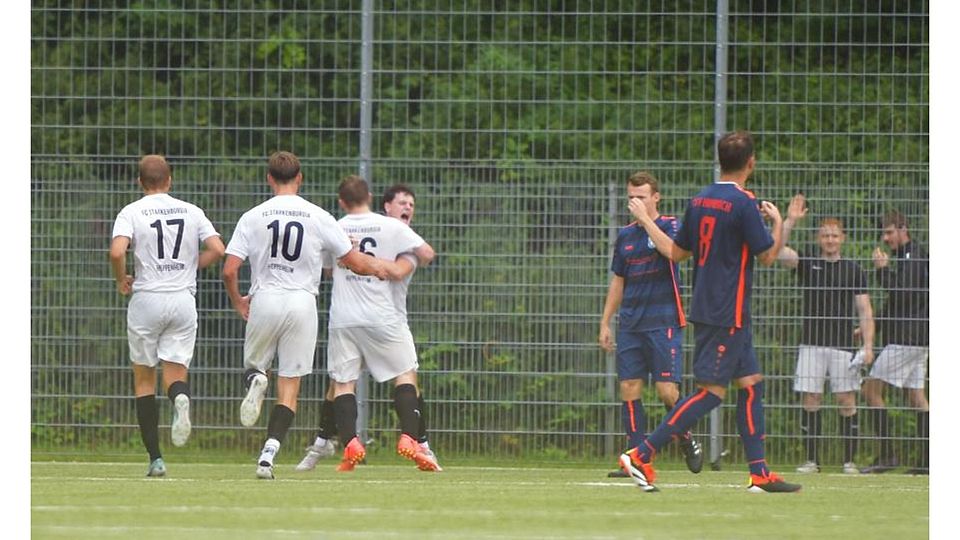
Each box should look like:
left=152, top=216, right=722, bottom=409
left=31, top=0, right=929, bottom=472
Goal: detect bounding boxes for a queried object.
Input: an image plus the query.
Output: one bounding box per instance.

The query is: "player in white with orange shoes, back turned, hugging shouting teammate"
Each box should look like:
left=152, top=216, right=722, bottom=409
left=327, top=176, right=439, bottom=471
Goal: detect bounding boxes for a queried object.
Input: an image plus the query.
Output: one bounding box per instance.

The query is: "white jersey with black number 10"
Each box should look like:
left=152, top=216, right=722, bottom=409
left=227, top=195, right=352, bottom=296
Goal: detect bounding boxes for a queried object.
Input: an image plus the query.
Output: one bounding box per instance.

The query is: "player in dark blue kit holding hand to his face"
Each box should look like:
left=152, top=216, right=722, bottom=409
left=599, top=171, right=703, bottom=476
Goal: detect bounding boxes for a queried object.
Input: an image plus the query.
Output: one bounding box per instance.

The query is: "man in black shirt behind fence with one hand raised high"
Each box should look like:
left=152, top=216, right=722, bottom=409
left=778, top=194, right=874, bottom=474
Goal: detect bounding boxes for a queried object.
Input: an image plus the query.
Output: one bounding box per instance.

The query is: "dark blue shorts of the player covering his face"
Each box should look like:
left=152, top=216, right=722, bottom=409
left=617, top=328, right=683, bottom=383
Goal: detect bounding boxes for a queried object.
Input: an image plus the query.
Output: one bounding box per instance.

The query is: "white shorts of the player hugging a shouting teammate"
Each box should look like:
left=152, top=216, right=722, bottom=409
left=327, top=322, right=419, bottom=383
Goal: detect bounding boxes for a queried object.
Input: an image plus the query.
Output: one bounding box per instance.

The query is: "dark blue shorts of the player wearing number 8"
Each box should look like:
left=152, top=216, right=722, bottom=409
left=693, top=323, right=760, bottom=386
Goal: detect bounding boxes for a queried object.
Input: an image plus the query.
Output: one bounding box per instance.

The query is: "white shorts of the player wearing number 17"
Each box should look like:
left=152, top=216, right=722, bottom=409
left=127, top=290, right=197, bottom=367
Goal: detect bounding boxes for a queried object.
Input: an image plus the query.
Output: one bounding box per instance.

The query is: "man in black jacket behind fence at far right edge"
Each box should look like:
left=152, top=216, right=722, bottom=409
left=861, top=210, right=930, bottom=474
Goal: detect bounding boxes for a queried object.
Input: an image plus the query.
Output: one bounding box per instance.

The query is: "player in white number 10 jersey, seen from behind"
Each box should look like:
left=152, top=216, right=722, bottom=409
left=223, top=152, right=386, bottom=479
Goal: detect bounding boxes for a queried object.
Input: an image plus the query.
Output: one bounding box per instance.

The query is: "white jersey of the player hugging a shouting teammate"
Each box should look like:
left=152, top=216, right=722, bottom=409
left=326, top=212, right=424, bottom=328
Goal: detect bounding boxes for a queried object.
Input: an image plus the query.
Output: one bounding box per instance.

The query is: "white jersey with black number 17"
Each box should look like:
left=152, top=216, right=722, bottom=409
left=113, top=193, right=218, bottom=294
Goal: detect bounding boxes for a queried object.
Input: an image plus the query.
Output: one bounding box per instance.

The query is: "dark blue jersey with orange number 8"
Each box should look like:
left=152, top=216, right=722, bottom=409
left=674, top=182, right=773, bottom=328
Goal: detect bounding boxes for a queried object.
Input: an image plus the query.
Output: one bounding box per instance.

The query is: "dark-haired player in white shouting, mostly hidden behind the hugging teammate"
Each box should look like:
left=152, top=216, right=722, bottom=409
left=296, top=184, right=442, bottom=471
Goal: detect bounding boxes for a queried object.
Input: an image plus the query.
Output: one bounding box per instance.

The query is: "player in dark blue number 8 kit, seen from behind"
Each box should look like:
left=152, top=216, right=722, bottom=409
left=620, top=131, right=800, bottom=493
